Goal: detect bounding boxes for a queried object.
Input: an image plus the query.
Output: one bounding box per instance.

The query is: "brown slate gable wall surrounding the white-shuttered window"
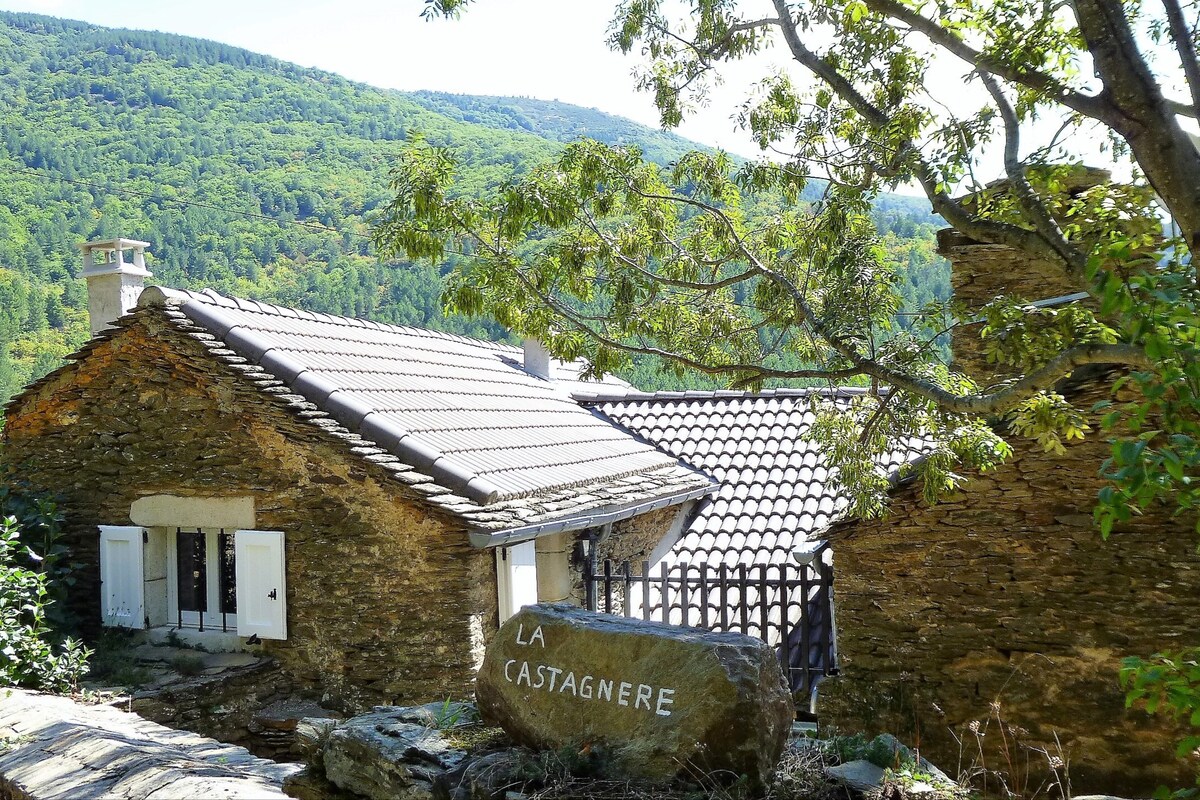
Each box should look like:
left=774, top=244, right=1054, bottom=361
left=0, top=309, right=496, bottom=711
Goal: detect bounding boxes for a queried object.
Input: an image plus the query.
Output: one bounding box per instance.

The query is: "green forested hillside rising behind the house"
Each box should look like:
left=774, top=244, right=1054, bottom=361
left=0, top=12, right=949, bottom=403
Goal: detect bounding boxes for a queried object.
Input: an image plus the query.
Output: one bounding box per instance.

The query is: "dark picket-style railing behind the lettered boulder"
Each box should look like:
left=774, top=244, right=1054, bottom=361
left=583, top=545, right=836, bottom=702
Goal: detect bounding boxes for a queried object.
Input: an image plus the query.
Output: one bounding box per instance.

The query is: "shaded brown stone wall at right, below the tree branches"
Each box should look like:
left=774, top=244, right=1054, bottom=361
left=817, top=387, right=1200, bottom=796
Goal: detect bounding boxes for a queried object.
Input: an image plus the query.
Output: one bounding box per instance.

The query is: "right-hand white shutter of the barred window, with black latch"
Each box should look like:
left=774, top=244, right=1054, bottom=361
left=233, top=530, right=288, bottom=639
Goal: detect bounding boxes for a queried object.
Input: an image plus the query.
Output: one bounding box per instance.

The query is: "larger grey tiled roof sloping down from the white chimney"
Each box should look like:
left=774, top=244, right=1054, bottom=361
left=130, top=287, right=713, bottom=534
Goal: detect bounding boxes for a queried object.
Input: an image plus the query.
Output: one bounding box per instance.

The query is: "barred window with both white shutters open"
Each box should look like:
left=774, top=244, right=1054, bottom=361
left=100, top=525, right=287, bottom=639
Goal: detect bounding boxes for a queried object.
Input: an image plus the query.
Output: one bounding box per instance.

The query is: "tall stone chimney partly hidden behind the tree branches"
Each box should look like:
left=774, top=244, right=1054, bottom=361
left=937, top=168, right=1110, bottom=385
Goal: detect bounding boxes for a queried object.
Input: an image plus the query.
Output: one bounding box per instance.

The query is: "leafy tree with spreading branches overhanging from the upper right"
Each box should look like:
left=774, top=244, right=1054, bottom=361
left=398, top=0, right=1200, bottom=535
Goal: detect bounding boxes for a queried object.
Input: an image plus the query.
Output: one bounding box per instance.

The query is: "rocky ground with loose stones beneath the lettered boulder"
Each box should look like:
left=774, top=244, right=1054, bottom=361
left=284, top=703, right=967, bottom=800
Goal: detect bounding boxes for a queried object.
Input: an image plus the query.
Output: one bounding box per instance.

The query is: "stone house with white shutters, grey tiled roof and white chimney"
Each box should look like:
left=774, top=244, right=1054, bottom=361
left=0, top=240, right=713, bottom=710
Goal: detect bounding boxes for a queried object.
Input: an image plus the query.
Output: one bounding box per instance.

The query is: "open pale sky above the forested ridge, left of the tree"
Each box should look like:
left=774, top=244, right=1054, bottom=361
left=0, top=0, right=773, bottom=155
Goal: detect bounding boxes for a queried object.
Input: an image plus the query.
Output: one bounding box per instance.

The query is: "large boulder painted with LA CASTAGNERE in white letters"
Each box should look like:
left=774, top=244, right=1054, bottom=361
left=475, top=604, right=794, bottom=786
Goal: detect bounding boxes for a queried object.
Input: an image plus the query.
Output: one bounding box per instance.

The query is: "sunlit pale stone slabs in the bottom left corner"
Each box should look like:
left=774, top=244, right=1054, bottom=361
left=0, top=690, right=300, bottom=800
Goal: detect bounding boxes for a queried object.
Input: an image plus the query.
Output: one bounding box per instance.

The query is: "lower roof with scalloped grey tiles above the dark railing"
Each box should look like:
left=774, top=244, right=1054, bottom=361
left=596, top=389, right=912, bottom=567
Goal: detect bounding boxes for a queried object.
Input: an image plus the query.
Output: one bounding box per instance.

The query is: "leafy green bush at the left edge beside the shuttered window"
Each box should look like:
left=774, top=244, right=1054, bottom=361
left=0, top=516, right=91, bottom=692
